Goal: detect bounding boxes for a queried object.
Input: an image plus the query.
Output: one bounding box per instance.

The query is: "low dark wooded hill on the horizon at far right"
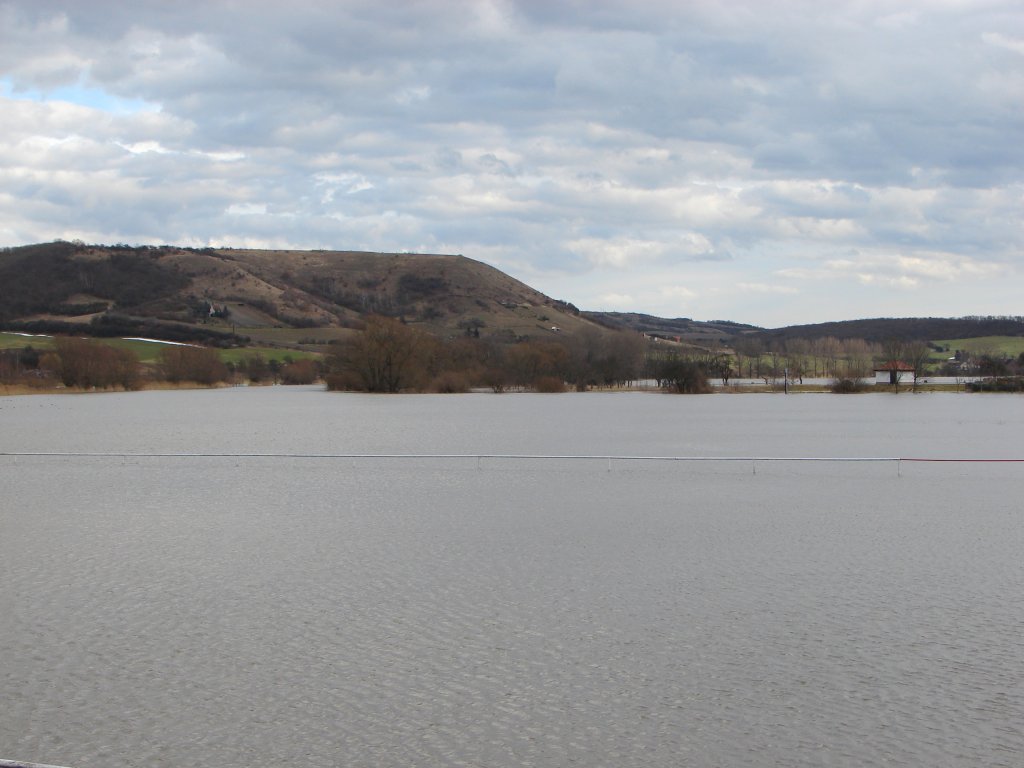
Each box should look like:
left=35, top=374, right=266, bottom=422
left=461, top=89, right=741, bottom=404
left=759, top=316, right=1024, bottom=342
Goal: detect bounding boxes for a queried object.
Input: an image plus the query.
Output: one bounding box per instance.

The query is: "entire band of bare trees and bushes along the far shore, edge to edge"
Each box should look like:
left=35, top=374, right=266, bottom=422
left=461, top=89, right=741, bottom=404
left=0, top=316, right=1024, bottom=393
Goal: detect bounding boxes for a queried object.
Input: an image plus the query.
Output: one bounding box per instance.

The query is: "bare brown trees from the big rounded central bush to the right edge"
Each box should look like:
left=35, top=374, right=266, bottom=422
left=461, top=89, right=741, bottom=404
left=325, top=316, right=1024, bottom=393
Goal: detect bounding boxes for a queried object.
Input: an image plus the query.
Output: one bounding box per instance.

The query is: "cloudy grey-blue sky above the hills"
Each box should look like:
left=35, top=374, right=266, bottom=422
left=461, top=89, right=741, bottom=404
left=0, top=0, right=1024, bottom=327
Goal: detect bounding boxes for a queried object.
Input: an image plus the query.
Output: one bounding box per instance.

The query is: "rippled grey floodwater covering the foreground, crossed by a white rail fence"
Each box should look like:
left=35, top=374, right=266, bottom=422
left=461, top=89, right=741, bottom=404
left=0, top=387, right=1024, bottom=768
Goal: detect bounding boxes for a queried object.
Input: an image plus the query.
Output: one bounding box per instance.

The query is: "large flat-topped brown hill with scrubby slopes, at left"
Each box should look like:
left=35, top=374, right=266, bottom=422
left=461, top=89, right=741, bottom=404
left=0, top=243, right=606, bottom=344
